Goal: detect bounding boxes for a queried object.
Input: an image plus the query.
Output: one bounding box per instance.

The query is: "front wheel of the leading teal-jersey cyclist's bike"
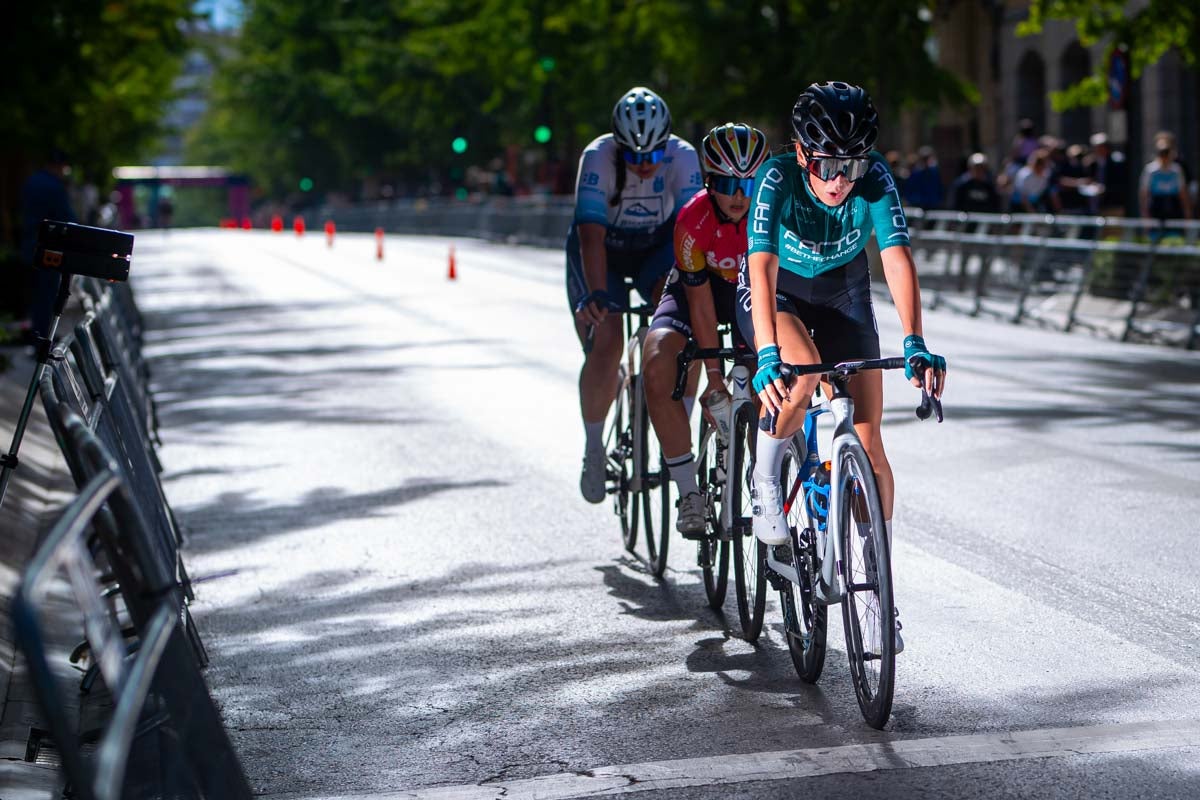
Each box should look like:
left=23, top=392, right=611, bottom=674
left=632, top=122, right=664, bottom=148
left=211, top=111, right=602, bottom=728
left=835, top=443, right=895, bottom=729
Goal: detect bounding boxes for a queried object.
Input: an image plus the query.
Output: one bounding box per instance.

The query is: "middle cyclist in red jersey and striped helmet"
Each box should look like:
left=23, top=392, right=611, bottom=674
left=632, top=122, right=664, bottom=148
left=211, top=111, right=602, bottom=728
left=642, top=122, right=769, bottom=536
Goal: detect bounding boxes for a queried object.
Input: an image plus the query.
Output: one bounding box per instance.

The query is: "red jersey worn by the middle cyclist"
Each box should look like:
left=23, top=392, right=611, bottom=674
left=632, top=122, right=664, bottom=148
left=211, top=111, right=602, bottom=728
left=674, top=190, right=749, bottom=284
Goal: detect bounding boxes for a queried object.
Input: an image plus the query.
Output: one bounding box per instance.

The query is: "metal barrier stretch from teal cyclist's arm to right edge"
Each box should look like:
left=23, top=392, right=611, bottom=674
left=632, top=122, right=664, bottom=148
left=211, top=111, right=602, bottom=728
left=911, top=211, right=1200, bottom=349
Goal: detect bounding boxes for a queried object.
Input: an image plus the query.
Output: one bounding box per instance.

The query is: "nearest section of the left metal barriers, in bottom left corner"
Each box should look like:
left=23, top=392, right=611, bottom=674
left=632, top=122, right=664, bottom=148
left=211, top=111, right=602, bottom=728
left=12, top=417, right=251, bottom=800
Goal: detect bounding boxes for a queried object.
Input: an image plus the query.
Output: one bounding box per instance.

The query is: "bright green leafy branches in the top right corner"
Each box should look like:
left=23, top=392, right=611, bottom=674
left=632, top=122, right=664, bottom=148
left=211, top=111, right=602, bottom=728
left=1016, top=0, right=1200, bottom=112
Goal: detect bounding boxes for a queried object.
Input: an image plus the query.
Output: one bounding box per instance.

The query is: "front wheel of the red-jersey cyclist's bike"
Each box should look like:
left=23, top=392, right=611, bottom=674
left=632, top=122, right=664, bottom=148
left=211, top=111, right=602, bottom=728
left=730, top=403, right=767, bottom=643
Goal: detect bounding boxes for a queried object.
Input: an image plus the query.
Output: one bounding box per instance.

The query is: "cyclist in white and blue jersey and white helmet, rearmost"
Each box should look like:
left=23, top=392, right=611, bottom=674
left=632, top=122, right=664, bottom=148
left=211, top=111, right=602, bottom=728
left=566, top=86, right=703, bottom=503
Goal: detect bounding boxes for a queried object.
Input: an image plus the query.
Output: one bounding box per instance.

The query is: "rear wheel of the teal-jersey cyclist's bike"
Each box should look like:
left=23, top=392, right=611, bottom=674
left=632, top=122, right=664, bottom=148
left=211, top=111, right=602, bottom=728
left=779, top=444, right=829, bottom=684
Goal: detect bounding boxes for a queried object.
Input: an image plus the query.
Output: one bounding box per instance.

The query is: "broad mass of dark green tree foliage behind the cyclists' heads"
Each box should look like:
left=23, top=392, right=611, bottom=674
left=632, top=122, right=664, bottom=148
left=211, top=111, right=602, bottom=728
left=193, top=0, right=976, bottom=192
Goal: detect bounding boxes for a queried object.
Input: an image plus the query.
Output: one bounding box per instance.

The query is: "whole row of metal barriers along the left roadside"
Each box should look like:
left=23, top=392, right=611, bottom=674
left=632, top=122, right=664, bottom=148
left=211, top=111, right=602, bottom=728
left=13, top=276, right=250, bottom=799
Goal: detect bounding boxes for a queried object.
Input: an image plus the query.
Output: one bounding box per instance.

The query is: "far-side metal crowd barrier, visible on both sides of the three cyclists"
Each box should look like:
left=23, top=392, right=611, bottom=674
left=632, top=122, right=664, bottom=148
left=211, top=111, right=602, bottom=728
left=319, top=197, right=1200, bottom=349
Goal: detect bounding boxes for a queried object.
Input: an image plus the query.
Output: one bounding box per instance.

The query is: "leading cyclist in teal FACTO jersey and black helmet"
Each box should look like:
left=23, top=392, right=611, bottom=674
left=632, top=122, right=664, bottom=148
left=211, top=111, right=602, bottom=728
left=738, top=82, right=946, bottom=651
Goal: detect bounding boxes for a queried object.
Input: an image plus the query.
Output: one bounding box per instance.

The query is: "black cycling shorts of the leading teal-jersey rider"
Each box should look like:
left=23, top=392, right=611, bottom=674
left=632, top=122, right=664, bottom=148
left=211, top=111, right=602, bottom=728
left=737, top=251, right=880, bottom=362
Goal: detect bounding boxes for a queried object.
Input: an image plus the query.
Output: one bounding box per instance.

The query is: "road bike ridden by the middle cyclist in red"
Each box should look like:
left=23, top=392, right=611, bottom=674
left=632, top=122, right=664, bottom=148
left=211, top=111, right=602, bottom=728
left=672, top=339, right=767, bottom=642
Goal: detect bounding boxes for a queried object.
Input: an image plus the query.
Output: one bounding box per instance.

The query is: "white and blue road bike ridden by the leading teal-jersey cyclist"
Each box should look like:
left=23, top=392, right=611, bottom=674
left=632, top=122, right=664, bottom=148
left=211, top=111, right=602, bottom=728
left=760, top=357, right=942, bottom=728
